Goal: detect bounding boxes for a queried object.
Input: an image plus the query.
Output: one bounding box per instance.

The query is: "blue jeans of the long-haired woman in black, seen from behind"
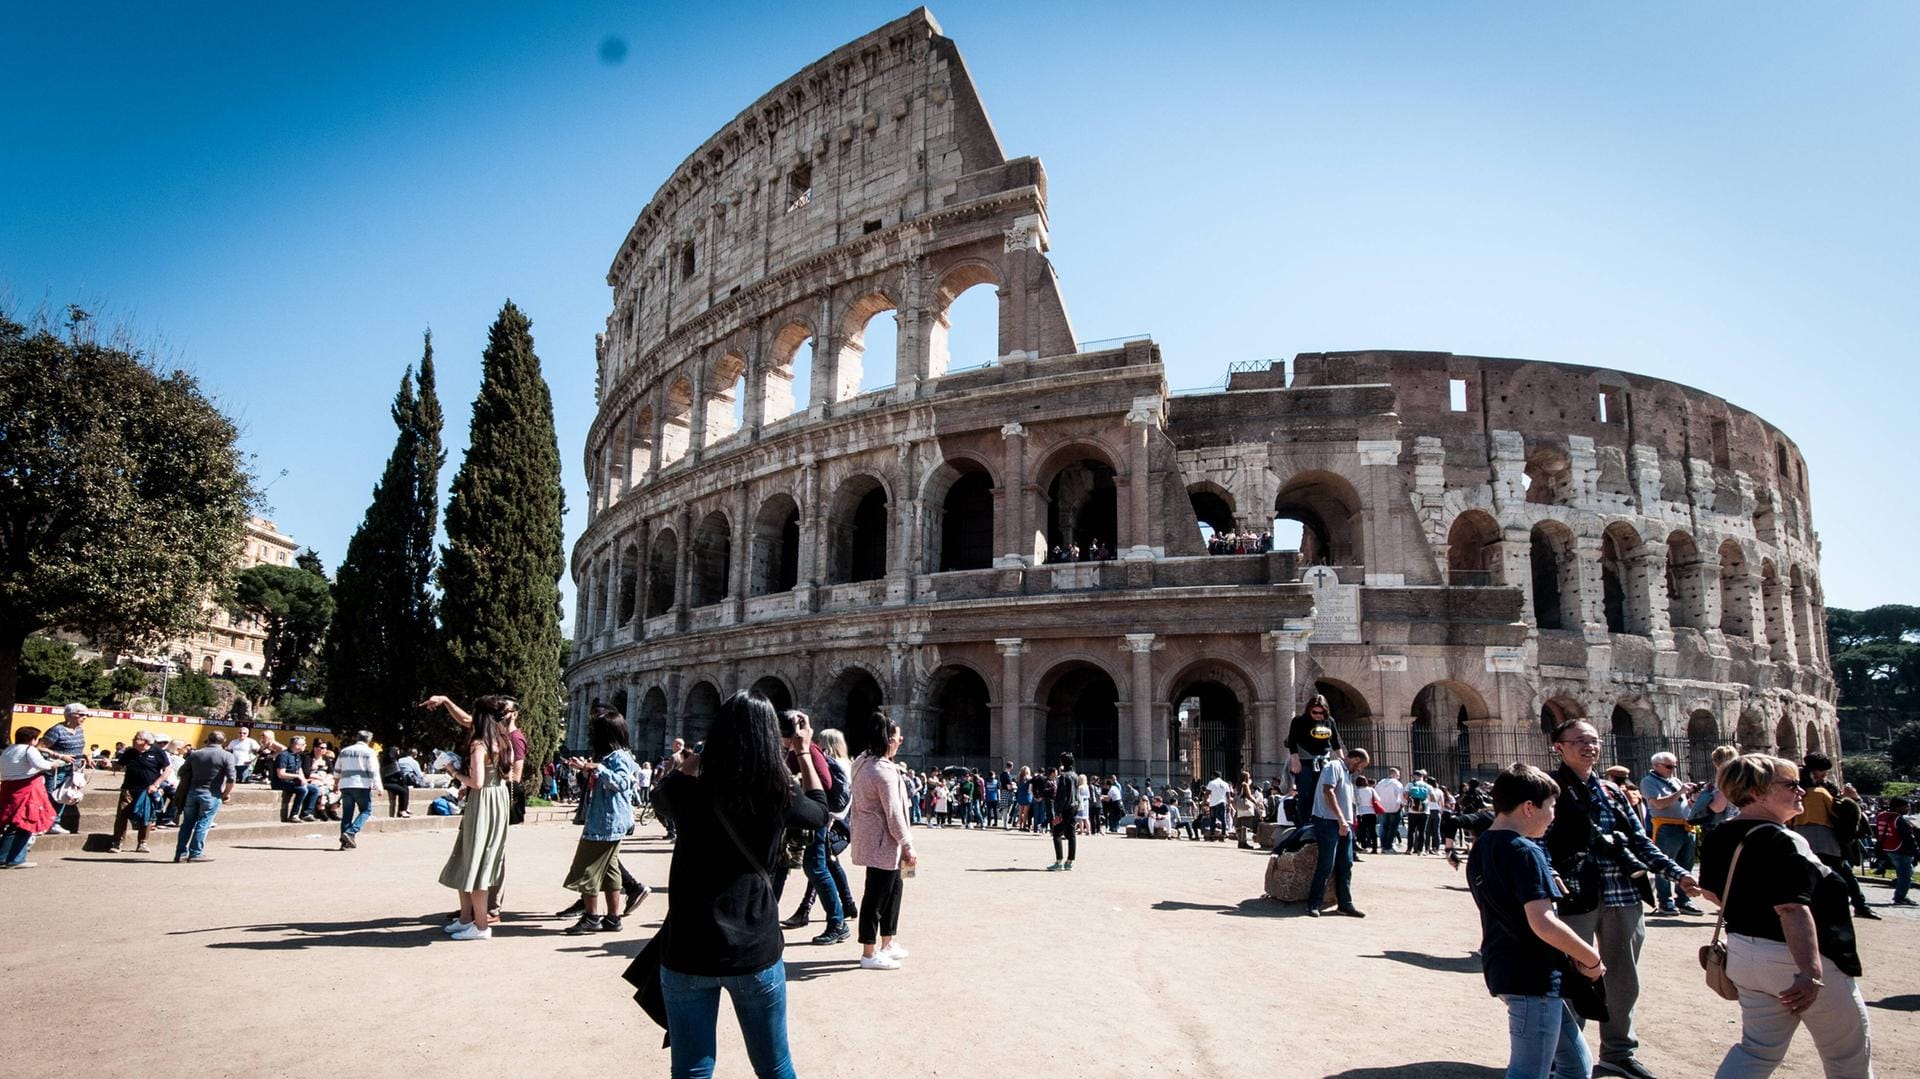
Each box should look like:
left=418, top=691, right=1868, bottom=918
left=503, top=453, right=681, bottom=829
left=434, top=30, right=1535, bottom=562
left=660, top=960, right=793, bottom=1079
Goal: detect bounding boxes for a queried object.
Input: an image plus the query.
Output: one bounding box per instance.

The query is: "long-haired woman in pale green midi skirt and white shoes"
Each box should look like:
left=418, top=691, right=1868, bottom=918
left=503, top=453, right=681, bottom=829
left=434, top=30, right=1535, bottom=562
left=426, top=695, right=520, bottom=941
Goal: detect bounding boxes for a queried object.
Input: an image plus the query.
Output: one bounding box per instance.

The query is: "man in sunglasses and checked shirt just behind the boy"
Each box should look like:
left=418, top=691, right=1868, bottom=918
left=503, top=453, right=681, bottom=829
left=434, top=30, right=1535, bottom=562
left=1546, top=720, right=1699, bottom=1079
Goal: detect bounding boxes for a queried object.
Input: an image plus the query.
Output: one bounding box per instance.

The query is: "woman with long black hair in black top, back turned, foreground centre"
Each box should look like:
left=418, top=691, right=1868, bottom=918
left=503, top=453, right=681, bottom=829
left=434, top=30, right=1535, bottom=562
left=653, top=693, right=828, bottom=1079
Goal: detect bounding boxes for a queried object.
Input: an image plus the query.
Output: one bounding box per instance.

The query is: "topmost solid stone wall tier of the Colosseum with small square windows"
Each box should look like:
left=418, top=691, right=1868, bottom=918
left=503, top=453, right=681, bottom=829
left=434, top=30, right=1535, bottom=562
left=607, top=8, right=1013, bottom=355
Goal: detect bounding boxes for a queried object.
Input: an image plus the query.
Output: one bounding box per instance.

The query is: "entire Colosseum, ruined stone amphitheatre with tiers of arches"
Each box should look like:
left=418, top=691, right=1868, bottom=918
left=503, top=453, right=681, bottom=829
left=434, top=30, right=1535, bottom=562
left=566, top=10, right=1837, bottom=779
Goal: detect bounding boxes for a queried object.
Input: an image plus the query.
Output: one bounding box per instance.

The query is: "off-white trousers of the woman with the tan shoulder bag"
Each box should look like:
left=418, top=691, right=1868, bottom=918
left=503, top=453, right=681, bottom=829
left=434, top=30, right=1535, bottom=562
left=1713, top=933, right=1874, bottom=1079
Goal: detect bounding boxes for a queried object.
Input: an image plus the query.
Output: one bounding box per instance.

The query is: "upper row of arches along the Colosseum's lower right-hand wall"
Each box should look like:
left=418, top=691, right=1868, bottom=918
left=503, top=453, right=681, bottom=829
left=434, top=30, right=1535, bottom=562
left=1446, top=509, right=1828, bottom=666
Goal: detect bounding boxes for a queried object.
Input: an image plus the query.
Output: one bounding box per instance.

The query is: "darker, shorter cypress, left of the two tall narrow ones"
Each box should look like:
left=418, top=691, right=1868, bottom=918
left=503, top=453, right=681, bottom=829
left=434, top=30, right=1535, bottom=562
left=324, top=332, right=447, bottom=743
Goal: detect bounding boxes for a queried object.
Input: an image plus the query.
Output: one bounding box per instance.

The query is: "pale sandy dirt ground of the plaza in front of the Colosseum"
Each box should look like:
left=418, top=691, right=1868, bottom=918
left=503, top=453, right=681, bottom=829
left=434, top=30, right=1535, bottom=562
left=0, top=810, right=1920, bottom=1079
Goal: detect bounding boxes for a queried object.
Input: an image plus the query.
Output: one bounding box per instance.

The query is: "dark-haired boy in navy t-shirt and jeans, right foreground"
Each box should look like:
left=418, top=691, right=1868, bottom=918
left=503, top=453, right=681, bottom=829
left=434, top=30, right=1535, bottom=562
left=1467, top=764, right=1605, bottom=1079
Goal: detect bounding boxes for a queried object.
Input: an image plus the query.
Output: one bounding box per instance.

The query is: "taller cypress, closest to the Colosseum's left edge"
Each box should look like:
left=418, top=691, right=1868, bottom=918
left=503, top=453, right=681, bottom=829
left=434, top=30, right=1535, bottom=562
left=440, top=301, right=566, bottom=776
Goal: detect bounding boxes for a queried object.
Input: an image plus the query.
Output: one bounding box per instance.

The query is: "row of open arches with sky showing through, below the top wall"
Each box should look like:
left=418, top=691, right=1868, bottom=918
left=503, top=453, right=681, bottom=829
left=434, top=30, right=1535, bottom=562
left=588, top=259, right=1004, bottom=513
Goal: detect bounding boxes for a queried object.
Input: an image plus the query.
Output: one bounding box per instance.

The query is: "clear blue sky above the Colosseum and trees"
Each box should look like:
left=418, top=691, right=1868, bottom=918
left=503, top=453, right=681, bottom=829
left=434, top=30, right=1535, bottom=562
left=0, top=2, right=1920, bottom=616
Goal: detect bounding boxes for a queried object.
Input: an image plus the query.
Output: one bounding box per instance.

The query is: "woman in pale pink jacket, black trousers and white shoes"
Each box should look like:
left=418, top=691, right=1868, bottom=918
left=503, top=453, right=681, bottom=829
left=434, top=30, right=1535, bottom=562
left=847, top=712, right=918, bottom=970
